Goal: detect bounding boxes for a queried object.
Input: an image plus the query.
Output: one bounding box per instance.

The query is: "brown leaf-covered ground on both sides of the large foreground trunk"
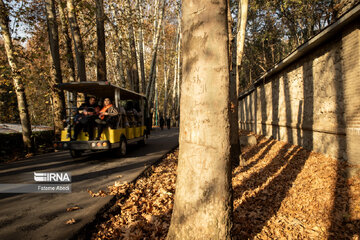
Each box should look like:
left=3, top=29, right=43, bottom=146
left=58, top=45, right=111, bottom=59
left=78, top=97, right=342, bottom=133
left=90, top=132, right=360, bottom=239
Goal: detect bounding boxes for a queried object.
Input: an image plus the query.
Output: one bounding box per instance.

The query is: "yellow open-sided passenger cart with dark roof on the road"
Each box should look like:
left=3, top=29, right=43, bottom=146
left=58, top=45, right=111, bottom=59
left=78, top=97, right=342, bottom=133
left=54, top=82, right=149, bottom=158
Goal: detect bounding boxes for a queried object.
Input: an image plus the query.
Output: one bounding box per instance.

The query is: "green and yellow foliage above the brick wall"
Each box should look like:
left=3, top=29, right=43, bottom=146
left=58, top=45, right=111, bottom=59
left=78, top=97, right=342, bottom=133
left=238, top=0, right=334, bottom=89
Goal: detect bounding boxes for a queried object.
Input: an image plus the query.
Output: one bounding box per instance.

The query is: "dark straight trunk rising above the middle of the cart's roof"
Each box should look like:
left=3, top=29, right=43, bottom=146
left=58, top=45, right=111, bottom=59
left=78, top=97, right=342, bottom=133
left=96, top=0, right=106, bottom=82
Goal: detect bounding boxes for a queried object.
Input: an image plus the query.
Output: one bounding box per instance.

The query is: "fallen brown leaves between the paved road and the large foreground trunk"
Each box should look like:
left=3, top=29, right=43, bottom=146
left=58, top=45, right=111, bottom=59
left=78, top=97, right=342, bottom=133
left=89, top=151, right=178, bottom=239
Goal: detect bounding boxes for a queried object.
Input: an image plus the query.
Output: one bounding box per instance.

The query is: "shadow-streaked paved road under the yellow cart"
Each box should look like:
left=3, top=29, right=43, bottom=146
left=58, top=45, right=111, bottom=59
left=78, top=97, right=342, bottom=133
left=0, top=129, right=178, bottom=239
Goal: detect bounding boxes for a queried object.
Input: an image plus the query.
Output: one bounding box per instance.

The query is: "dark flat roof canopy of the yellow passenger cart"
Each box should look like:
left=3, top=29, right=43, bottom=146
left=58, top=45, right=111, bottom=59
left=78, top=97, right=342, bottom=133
left=57, top=82, right=145, bottom=100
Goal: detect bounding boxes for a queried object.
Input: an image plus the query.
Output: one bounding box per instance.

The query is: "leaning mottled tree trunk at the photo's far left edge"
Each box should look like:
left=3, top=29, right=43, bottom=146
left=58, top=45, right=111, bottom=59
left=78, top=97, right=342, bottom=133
left=0, top=0, right=34, bottom=152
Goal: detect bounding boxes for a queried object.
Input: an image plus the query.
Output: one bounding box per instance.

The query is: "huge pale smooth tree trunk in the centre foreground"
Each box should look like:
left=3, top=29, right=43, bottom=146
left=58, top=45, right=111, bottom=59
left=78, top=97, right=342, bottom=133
left=167, top=0, right=232, bottom=239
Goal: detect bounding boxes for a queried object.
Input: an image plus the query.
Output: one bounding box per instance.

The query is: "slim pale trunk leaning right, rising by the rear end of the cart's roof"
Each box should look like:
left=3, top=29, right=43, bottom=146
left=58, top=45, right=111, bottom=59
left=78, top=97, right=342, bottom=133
left=146, top=0, right=166, bottom=99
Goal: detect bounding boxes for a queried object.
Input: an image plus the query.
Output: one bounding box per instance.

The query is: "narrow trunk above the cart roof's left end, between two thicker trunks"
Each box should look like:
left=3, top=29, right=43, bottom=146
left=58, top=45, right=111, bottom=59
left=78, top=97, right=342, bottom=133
left=59, top=2, right=75, bottom=82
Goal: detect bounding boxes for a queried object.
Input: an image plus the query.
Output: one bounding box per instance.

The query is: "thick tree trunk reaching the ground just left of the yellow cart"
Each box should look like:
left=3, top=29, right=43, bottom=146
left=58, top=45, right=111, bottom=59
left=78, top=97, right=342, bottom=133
left=45, top=0, right=65, bottom=140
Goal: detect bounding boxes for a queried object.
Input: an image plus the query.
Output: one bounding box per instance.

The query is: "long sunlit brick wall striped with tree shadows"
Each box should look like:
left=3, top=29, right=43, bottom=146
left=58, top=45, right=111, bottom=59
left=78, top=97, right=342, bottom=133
left=239, top=8, right=360, bottom=176
